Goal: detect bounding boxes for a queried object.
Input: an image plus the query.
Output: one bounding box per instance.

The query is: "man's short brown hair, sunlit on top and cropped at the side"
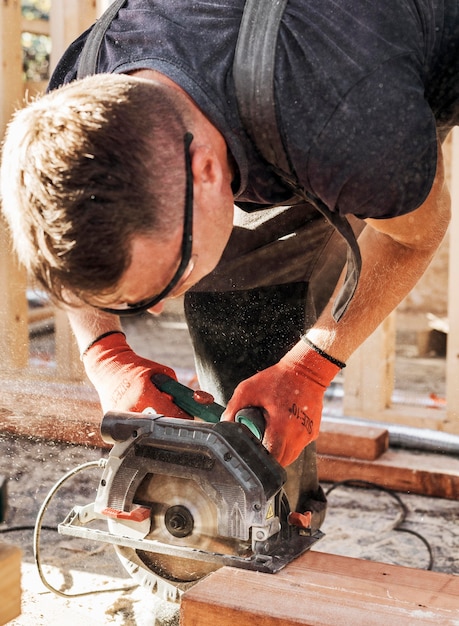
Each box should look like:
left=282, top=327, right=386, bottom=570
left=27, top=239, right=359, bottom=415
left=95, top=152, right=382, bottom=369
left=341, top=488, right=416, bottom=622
left=1, top=75, right=194, bottom=301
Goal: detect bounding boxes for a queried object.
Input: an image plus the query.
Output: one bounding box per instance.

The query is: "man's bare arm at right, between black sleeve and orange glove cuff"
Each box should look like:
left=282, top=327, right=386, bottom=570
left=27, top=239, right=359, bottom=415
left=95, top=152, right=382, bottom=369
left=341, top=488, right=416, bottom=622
left=307, top=140, right=450, bottom=362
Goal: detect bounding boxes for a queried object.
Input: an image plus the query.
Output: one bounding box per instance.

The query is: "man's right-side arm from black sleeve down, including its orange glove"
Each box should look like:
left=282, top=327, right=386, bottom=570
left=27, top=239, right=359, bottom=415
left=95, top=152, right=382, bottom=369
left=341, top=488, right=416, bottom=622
left=224, top=141, right=450, bottom=465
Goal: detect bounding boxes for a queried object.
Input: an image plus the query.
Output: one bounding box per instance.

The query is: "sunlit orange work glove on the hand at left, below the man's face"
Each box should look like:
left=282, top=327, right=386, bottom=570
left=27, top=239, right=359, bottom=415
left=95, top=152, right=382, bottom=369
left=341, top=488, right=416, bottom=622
left=83, top=331, right=192, bottom=419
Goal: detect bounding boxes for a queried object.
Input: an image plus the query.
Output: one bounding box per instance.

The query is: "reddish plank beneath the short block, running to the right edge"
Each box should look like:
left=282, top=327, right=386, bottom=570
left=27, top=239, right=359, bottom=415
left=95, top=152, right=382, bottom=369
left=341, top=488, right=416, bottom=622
left=317, top=449, right=459, bottom=500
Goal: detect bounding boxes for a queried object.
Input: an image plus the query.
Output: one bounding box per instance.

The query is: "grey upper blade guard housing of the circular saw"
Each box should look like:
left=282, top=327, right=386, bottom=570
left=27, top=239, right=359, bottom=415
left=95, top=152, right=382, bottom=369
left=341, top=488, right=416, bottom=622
left=95, top=413, right=286, bottom=549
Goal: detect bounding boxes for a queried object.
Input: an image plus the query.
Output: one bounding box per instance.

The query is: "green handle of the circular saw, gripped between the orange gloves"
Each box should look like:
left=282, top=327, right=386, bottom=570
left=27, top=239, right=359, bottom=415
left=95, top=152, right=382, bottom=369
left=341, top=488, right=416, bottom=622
left=151, top=374, right=266, bottom=441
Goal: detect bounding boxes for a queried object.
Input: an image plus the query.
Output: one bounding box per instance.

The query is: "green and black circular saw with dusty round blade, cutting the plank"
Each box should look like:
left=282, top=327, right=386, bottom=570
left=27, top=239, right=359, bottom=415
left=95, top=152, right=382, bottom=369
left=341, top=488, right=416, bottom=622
left=58, top=379, right=323, bottom=600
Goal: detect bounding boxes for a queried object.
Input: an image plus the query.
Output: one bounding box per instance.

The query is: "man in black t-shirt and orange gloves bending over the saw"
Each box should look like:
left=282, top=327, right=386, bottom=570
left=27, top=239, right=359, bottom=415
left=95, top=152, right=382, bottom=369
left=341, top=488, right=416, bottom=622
left=2, top=0, right=452, bottom=509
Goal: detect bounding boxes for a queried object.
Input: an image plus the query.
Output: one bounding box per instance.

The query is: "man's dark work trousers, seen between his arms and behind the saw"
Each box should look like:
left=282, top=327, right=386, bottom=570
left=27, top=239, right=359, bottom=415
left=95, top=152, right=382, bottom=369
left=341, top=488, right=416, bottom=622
left=185, top=204, right=359, bottom=527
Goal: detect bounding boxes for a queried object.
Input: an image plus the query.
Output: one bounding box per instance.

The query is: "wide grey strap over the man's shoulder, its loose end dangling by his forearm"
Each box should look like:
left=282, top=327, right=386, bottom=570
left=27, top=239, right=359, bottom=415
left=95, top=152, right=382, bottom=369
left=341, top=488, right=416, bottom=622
left=233, top=0, right=362, bottom=321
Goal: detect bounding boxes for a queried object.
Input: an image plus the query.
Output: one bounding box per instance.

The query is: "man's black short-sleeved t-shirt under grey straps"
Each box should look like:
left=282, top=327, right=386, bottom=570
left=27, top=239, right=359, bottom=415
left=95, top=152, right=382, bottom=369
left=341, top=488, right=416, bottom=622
left=50, top=0, right=459, bottom=218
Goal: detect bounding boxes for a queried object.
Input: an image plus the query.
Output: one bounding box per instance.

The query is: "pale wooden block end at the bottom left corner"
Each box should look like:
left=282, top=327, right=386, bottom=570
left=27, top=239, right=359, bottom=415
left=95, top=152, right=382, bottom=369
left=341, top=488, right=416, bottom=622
left=0, top=543, right=21, bottom=624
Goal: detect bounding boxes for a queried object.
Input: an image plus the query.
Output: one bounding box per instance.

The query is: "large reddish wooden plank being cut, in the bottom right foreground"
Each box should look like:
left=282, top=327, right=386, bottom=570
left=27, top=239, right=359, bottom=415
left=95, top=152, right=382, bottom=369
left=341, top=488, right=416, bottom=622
left=180, top=552, right=459, bottom=626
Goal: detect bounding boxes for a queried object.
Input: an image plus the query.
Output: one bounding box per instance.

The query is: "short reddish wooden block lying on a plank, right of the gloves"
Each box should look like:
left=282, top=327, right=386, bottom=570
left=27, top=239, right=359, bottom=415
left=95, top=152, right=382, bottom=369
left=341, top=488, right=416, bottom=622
left=317, top=420, right=389, bottom=461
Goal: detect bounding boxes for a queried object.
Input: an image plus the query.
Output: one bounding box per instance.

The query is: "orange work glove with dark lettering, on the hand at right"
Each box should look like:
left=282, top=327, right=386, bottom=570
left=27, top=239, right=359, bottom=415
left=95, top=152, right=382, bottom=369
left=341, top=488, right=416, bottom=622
left=223, top=338, right=344, bottom=467
